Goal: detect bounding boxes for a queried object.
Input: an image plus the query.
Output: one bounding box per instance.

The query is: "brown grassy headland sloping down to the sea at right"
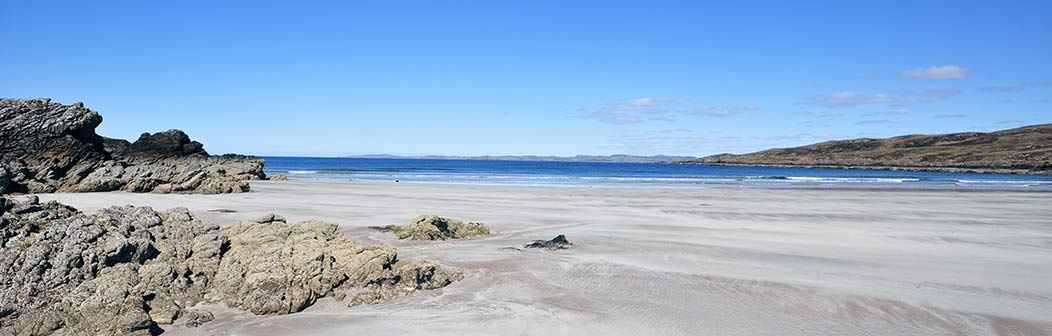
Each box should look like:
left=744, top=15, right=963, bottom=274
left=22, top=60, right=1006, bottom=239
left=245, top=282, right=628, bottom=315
left=680, top=124, right=1052, bottom=175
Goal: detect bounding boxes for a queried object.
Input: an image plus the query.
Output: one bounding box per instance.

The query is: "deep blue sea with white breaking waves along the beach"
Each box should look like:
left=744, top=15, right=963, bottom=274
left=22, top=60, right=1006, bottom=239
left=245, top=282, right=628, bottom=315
left=264, top=157, right=1052, bottom=192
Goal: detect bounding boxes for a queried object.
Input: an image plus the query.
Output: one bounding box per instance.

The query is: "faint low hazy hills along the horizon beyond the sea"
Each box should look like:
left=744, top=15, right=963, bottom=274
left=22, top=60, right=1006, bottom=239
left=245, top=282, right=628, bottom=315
left=344, top=154, right=694, bottom=163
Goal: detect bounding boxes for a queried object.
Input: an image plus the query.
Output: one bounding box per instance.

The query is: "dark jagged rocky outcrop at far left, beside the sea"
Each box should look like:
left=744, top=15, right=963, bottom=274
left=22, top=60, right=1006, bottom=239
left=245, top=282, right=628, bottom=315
left=0, top=99, right=266, bottom=194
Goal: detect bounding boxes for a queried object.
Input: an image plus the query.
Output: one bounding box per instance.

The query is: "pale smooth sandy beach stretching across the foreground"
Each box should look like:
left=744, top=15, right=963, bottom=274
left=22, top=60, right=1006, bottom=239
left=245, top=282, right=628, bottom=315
left=30, top=180, right=1052, bottom=335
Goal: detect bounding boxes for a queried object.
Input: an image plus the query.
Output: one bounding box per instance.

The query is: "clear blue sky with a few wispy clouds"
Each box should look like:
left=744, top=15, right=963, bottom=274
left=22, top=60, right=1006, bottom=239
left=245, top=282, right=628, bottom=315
left=0, top=0, right=1052, bottom=156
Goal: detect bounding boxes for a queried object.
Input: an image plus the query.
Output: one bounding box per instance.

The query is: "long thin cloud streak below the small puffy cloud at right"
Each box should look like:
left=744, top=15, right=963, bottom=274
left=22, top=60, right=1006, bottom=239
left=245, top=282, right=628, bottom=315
left=801, top=88, right=960, bottom=107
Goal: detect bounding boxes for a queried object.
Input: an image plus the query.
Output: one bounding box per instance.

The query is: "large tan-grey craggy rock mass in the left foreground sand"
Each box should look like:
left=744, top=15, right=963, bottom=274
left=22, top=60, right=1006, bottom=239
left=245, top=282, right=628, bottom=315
left=0, top=198, right=462, bottom=335
